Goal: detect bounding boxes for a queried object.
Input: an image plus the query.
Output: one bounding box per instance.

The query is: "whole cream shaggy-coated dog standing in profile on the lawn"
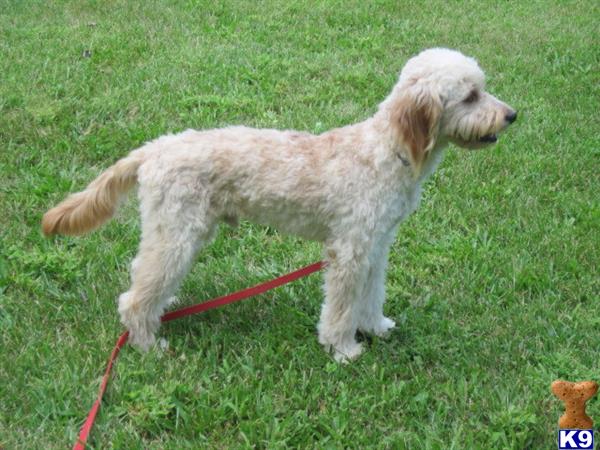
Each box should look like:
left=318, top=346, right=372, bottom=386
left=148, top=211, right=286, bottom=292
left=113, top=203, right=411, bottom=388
left=42, top=48, right=517, bottom=360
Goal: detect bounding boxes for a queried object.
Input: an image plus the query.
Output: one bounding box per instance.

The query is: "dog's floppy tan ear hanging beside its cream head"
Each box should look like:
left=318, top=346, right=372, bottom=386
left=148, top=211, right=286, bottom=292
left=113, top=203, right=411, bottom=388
left=391, top=85, right=442, bottom=173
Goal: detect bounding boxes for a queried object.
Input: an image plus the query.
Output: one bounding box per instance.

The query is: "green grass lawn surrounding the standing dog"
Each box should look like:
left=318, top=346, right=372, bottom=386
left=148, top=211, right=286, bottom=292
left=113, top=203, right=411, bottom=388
left=0, top=0, right=600, bottom=449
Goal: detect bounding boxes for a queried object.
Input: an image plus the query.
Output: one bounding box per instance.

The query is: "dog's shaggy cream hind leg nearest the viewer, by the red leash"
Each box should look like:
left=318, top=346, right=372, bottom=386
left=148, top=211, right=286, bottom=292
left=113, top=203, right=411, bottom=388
left=119, top=180, right=216, bottom=350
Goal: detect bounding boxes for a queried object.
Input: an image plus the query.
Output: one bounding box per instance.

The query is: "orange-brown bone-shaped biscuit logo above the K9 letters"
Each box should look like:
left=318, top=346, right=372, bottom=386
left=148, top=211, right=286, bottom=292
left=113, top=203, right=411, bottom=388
left=551, top=380, right=598, bottom=430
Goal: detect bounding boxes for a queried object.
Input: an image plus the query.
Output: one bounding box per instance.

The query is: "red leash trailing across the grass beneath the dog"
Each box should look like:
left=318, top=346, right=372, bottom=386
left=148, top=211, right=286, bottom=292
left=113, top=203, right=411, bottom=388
left=73, top=261, right=325, bottom=450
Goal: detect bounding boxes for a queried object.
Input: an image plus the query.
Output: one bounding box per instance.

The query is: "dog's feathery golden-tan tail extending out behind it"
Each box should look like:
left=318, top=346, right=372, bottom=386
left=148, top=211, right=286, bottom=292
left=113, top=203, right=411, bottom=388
left=42, top=151, right=143, bottom=236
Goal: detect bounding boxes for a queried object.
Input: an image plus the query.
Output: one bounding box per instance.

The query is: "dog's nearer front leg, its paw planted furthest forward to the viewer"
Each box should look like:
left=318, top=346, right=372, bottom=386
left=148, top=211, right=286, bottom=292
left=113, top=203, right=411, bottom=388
left=318, top=242, right=368, bottom=362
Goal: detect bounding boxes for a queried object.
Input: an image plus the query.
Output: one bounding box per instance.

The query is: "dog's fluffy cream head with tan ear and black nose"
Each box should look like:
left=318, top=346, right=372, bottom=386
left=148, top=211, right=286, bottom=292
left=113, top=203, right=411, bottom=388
left=382, top=48, right=517, bottom=171
